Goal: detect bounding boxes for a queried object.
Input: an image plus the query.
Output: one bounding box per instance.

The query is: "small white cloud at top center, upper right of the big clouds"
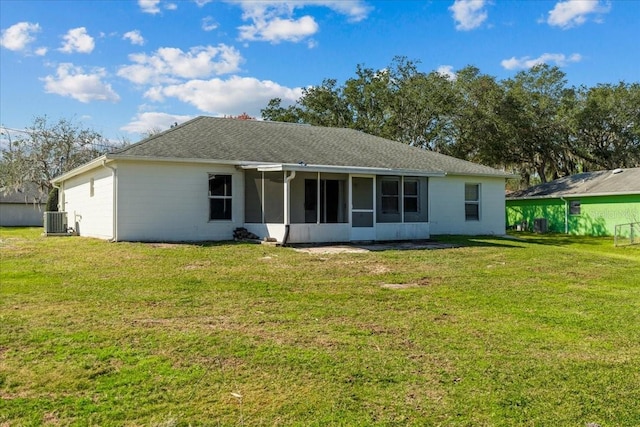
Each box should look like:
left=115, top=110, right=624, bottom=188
left=238, top=16, right=319, bottom=43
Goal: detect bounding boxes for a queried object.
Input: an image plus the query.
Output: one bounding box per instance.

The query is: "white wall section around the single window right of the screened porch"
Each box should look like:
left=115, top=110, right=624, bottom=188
left=429, top=176, right=506, bottom=235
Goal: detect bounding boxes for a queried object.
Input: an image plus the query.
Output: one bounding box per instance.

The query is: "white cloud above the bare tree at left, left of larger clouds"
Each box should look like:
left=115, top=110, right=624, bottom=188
left=42, top=63, right=120, bottom=103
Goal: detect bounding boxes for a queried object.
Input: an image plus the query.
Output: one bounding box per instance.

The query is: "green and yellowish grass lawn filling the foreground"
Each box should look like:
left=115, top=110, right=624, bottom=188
left=0, top=228, right=640, bottom=427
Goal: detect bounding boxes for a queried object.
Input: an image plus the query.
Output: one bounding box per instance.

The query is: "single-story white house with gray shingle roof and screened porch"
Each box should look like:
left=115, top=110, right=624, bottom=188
left=53, top=117, right=513, bottom=243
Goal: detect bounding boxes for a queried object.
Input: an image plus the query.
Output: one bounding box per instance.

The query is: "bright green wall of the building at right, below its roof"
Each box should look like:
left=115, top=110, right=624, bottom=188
left=506, top=194, right=640, bottom=236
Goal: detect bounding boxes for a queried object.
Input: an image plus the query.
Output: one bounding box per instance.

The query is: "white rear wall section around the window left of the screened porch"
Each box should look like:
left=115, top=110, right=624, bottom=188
left=117, top=161, right=244, bottom=241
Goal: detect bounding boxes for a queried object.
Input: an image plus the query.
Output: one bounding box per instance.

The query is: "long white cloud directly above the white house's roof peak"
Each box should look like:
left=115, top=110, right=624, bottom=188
left=145, top=76, right=302, bottom=117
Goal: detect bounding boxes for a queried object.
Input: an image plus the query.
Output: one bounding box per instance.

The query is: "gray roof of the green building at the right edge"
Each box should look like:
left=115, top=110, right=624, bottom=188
left=508, top=168, right=640, bottom=200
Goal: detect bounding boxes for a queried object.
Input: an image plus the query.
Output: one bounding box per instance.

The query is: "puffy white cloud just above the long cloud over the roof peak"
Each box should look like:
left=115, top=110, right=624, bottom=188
left=118, top=44, right=243, bottom=85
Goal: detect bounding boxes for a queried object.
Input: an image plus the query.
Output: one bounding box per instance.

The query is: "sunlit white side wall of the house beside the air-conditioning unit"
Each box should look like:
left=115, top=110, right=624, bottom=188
left=60, top=167, right=113, bottom=239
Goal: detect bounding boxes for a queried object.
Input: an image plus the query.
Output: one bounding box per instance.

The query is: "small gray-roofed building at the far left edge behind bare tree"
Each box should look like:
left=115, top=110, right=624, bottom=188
left=0, top=186, right=47, bottom=227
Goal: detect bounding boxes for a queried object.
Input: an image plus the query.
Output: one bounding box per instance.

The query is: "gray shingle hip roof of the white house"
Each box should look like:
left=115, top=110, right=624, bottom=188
left=111, top=116, right=511, bottom=177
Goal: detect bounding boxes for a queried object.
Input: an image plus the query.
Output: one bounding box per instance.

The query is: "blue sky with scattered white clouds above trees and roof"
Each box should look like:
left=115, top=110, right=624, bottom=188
left=0, top=0, right=640, bottom=142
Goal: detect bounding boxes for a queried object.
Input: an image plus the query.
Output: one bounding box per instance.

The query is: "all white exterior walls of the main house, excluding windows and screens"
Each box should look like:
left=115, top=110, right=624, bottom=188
left=63, top=160, right=505, bottom=243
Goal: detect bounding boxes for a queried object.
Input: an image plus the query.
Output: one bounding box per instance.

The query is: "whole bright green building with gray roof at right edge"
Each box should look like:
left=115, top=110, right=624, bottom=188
left=506, top=168, right=640, bottom=236
